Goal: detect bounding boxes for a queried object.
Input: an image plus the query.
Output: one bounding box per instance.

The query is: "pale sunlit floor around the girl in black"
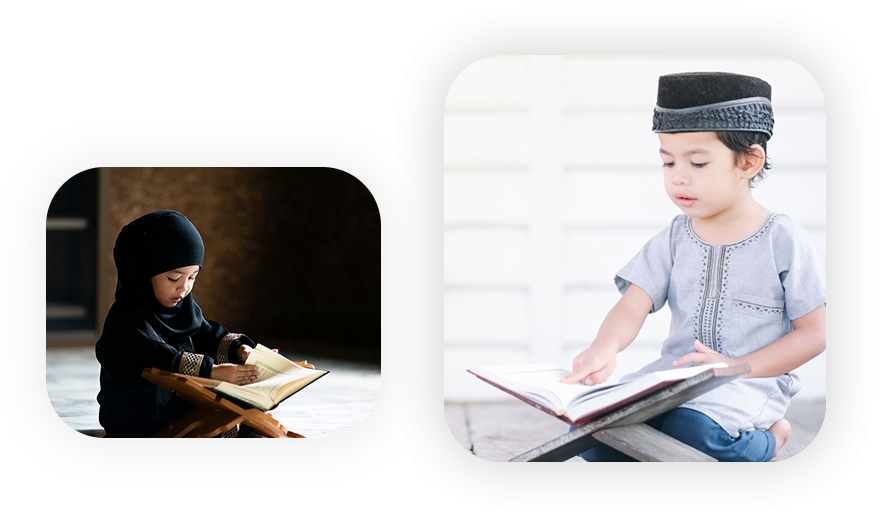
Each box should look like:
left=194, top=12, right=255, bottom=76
left=46, top=347, right=382, bottom=437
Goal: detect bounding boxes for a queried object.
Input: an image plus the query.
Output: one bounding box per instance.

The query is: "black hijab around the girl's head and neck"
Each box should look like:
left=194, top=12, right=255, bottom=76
left=114, top=210, right=204, bottom=342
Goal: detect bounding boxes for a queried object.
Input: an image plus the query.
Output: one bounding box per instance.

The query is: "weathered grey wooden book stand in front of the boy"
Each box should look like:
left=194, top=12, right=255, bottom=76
left=509, top=364, right=750, bottom=462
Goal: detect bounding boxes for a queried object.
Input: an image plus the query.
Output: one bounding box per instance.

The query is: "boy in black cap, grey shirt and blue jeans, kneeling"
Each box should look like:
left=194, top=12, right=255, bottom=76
left=562, top=73, right=826, bottom=462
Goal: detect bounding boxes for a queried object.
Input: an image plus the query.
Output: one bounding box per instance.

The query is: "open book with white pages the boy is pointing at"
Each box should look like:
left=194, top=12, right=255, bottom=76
left=468, top=364, right=727, bottom=425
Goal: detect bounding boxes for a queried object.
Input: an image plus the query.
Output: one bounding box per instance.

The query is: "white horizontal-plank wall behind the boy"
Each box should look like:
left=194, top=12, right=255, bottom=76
left=444, top=56, right=826, bottom=401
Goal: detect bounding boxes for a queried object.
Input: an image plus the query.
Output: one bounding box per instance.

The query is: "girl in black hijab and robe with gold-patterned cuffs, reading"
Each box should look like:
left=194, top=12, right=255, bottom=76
left=96, top=210, right=256, bottom=437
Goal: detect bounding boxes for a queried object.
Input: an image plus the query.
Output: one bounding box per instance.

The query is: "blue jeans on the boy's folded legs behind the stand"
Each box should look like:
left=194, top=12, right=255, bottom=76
left=570, top=408, right=777, bottom=462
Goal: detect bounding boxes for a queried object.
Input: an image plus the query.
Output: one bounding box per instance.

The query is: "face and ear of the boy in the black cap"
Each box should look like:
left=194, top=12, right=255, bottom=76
left=659, top=132, right=765, bottom=218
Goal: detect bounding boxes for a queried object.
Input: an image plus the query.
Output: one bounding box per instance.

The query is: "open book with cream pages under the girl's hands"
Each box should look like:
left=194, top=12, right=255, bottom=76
left=208, top=344, right=330, bottom=410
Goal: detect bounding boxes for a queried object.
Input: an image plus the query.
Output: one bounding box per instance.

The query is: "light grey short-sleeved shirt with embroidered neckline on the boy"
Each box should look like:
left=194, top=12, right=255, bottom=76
left=614, top=213, right=826, bottom=437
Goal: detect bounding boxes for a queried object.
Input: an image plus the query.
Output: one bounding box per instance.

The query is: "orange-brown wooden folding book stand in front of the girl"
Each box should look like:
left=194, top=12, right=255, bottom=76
left=142, top=367, right=304, bottom=437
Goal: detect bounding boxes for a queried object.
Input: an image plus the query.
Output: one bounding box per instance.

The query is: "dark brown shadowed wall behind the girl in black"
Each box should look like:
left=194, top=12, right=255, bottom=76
left=99, top=167, right=381, bottom=361
